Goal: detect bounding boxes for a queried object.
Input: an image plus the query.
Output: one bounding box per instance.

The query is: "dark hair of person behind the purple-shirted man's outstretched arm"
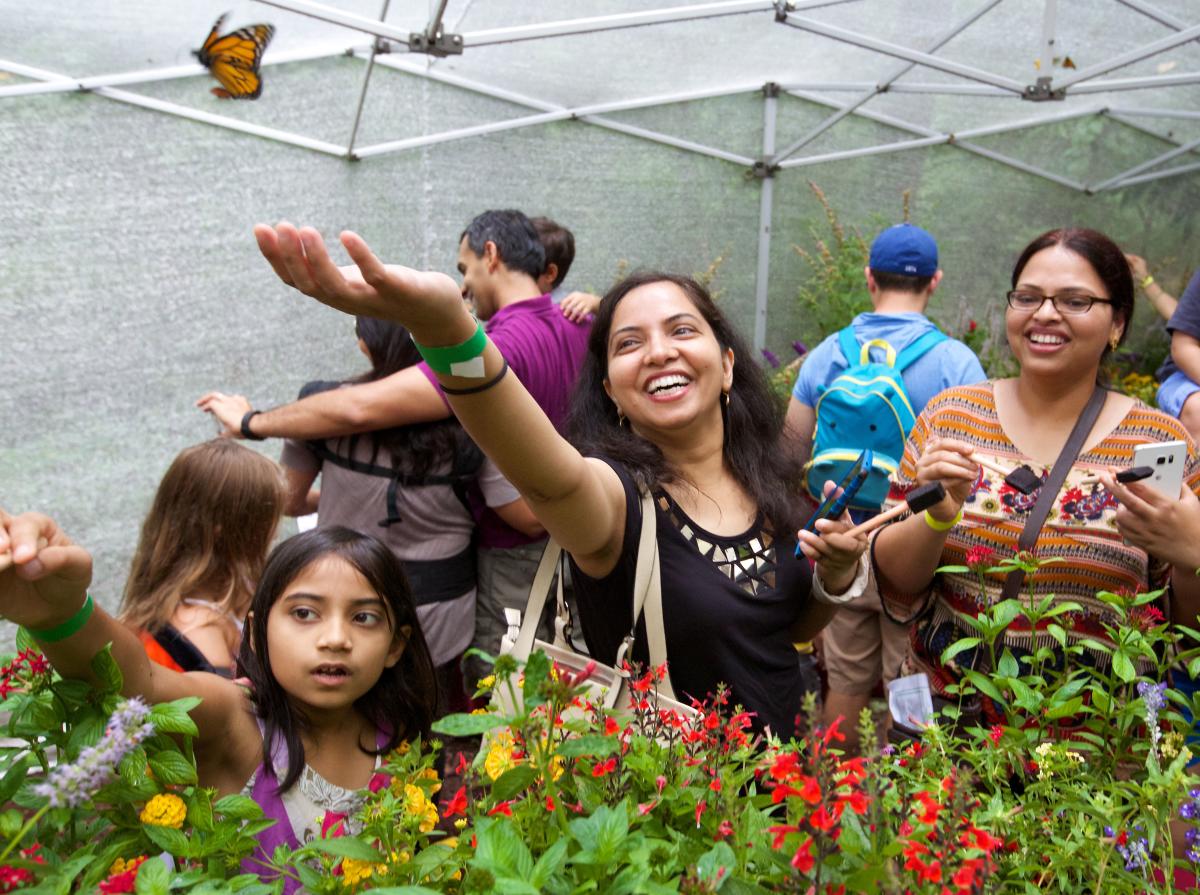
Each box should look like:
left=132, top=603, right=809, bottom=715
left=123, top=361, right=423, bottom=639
left=350, top=317, right=484, bottom=477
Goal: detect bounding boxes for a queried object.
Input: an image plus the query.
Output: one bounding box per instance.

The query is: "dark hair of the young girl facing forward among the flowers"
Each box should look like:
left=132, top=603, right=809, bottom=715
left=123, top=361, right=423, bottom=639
left=238, top=525, right=438, bottom=792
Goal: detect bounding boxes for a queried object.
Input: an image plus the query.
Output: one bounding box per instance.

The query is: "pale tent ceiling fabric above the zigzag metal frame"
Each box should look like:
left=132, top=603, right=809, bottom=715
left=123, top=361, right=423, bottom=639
left=0, top=0, right=1200, bottom=192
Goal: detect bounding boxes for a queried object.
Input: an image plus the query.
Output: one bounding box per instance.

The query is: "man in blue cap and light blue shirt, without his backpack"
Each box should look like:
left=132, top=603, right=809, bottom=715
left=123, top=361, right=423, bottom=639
left=787, top=223, right=986, bottom=747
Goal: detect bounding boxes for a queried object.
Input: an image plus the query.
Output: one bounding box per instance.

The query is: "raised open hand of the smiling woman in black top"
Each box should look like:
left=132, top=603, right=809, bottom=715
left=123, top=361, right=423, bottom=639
left=254, top=222, right=475, bottom=346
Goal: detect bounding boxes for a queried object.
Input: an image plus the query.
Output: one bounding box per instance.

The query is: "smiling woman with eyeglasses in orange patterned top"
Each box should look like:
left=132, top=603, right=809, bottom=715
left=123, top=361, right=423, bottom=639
left=871, top=229, right=1200, bottom=722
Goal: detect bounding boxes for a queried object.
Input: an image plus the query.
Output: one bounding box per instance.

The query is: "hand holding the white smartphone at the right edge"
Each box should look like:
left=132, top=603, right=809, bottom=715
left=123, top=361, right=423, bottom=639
left=1099, top=471, right=1200, bottom=571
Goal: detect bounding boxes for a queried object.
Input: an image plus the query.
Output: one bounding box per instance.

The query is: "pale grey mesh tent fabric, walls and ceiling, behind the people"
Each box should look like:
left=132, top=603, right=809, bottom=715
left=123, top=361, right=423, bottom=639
left=0, top=0, right=1200, bottom=636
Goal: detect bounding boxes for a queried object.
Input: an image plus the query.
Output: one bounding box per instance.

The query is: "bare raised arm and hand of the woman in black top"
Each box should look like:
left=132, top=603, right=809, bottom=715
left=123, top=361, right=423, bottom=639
left=254, top=223, right=625, bottom=575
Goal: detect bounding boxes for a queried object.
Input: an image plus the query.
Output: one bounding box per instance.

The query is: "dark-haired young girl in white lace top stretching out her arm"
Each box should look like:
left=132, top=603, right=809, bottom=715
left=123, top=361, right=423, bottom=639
left=0, top=510, right=437, bottom=891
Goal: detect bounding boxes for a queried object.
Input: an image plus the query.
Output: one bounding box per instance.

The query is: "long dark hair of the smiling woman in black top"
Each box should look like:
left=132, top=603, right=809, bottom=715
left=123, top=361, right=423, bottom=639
left=568, top=271, right=802, bottom=534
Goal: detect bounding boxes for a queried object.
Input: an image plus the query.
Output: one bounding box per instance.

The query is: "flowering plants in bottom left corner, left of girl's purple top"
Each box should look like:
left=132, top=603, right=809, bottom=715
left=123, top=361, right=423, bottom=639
left=0, top=632, right=270, bottom=895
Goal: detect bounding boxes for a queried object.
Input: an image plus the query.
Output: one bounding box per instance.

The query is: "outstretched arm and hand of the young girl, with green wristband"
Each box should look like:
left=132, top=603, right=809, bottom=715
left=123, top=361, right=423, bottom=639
left=0, top=510, right=260, bottom=755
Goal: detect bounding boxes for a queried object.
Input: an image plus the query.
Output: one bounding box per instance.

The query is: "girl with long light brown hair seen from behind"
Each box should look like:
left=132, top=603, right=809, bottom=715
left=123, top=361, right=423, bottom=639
left=120, top=439, right=284, bottom=677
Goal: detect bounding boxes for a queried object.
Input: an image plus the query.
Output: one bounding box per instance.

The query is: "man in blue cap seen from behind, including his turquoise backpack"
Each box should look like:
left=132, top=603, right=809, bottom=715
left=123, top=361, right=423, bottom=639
left=786, top=223, right=986, bottom=746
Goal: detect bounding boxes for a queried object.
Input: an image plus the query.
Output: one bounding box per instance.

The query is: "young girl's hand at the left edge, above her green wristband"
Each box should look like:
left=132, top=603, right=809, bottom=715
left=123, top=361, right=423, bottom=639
left=0, top=510, right=91, bottom=629
